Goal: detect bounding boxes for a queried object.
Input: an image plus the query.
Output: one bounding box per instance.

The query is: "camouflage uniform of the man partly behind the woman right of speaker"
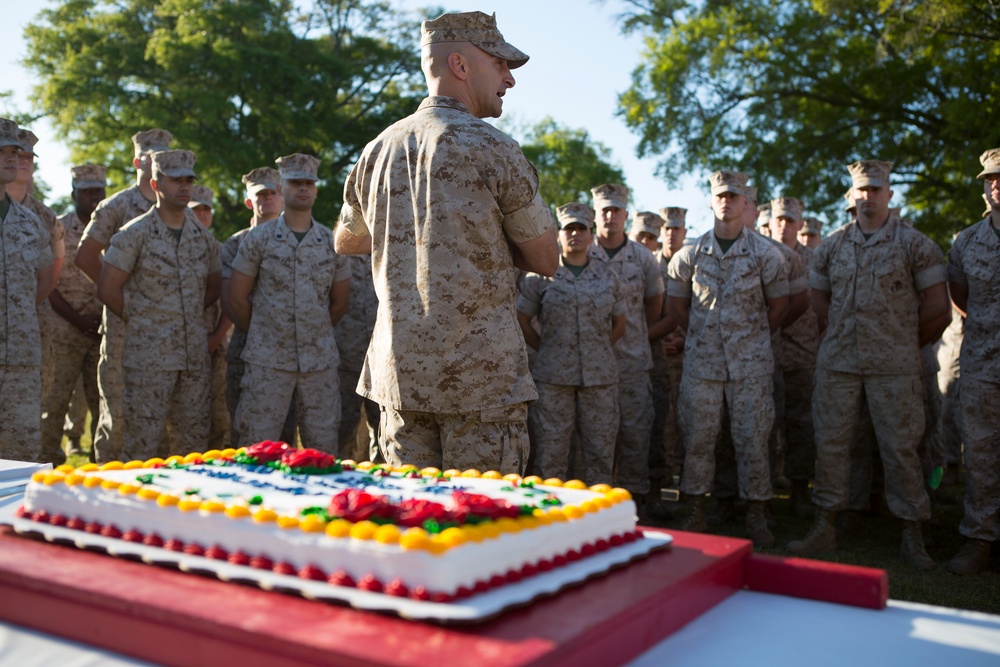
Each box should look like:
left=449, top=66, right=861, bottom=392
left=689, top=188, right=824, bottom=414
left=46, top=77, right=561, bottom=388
left=590, top=239, right=664, bottom=495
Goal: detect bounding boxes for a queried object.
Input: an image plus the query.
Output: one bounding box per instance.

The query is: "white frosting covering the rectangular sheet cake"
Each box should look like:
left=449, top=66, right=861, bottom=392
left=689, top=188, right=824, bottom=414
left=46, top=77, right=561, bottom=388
left=25, top=466, right=635, bottom=593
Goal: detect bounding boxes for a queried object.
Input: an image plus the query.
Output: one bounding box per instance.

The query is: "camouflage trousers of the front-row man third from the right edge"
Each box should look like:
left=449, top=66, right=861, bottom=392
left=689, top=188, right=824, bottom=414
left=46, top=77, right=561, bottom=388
left=677, top=373, right=774, bottom=500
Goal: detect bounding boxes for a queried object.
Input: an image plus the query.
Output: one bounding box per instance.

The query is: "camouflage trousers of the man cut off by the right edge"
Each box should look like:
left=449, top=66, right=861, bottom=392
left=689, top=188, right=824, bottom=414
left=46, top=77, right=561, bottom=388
left=959, top=374, right=1000, bottom=542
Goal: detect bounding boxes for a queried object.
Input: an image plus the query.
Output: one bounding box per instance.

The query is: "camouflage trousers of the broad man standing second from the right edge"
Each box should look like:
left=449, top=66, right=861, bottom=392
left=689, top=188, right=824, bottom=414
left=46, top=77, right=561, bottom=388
left=813, top=369, right=931, bottom=521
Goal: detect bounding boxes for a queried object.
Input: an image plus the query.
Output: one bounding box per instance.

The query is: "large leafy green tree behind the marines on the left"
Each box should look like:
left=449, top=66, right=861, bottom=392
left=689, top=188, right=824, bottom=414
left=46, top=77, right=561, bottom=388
left=25, top=0, right=424, bottom=234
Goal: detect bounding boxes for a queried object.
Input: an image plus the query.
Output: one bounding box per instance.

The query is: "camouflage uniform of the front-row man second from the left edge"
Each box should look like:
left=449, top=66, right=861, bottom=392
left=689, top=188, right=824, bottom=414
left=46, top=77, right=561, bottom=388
left=104, top=208, right=221, bottom=459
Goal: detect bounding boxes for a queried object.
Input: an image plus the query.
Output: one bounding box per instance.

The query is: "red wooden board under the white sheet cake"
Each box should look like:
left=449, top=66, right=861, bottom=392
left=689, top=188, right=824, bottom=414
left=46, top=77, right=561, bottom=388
left=0, top=526, right=888, bottom=667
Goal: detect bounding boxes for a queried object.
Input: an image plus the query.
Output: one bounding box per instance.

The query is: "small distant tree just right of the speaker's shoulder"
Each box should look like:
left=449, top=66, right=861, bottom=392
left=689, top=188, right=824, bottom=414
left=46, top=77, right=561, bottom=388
left=521, top=118, right=625, bottom=208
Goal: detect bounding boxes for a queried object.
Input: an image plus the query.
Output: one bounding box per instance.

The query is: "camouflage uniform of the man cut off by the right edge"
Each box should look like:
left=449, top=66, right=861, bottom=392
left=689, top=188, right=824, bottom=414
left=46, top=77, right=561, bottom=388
left=948, top=219, right=1000, bottom=542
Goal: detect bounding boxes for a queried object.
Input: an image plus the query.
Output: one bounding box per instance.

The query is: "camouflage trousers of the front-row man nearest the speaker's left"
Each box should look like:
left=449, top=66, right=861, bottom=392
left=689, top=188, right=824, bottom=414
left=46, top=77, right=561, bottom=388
left=236, top=363, right=340, bottom=456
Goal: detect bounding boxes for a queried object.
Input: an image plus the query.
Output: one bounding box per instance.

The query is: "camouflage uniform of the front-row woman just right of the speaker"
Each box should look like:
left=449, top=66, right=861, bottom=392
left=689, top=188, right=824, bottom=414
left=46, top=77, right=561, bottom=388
left=517, top=258, right=626, bottom=484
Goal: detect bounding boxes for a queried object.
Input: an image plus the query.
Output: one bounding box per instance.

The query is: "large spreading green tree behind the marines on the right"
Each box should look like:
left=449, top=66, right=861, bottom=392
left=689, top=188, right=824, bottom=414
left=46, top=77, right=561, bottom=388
left=620, top=0, right=1000, bottom=242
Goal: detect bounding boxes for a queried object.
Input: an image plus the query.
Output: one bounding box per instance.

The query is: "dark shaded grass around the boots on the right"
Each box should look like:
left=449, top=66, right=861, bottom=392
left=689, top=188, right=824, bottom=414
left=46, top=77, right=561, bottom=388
left=647, top=474, right=1000, bottom=614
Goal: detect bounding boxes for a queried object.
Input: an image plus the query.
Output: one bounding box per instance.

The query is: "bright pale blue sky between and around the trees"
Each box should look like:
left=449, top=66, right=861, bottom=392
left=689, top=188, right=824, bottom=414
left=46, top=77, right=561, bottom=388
left=0, top=0, right=712, bottom=235
